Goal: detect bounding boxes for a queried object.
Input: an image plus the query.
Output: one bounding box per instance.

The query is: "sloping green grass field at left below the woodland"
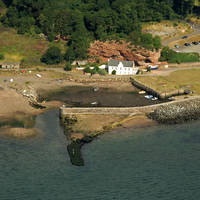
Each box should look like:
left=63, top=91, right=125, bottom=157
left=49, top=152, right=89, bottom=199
left=0, top=25, right=65, bottom=67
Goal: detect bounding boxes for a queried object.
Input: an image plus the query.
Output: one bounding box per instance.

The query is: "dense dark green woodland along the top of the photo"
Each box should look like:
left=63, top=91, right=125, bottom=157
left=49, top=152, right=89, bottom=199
left=1, top=0, right=198, bottom=60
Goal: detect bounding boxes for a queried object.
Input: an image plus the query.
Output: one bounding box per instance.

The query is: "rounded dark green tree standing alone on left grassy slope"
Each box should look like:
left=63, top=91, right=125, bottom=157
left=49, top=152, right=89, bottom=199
left=40, top=47, right=63, bottom=65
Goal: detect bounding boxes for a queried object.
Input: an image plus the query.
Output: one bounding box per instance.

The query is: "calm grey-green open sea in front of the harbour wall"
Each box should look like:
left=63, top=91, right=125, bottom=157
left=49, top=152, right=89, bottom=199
left=0, top=111, right=200, bottom=200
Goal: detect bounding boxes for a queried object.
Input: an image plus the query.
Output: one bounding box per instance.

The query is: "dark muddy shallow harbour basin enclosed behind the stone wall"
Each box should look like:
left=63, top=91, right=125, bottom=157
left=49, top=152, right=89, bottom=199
left=39, top=86, right=163, bottom=107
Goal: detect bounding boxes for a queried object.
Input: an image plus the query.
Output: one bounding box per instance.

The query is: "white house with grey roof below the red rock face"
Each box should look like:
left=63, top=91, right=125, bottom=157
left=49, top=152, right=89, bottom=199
left=108, top=60, right=139, bottom=75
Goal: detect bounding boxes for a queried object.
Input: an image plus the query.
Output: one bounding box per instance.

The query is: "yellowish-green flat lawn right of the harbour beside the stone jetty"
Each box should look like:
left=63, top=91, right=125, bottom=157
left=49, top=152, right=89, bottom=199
left=135, top=69, right=200, bottom=94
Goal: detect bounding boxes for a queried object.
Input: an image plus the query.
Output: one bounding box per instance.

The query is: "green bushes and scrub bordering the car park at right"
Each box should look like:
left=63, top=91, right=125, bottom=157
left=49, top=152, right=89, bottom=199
left=159, top=47, right=199, bottom=63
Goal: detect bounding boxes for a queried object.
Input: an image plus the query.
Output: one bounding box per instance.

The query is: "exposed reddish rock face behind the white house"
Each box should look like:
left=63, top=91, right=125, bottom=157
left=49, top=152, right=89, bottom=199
left=89, top=41, right=160, bottom=65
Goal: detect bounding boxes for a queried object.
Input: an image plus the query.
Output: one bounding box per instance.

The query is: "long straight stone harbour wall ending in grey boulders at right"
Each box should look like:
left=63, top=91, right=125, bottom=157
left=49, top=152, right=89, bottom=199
left=60, top=96, right=200, bottom=124
